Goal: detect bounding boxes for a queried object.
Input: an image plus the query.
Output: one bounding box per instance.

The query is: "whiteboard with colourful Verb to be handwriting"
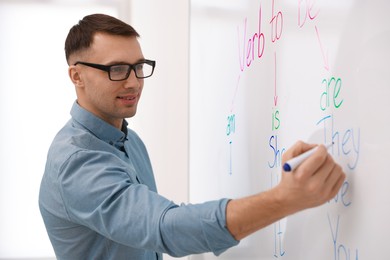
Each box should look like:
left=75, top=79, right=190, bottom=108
left=189, top=0, right=390, bottom=260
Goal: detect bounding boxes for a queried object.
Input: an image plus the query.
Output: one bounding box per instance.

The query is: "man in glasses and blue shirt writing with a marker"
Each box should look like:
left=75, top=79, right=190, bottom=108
left=39, top=14, right=345, bottom=260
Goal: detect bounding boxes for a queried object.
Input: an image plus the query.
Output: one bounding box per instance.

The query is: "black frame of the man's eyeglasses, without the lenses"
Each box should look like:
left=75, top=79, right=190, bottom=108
left=73, top=60, right=156, bottom=81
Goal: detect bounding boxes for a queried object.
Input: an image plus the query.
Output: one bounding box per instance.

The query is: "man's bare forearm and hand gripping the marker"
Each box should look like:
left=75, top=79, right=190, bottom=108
left=226, top=142, right=345, bottom=240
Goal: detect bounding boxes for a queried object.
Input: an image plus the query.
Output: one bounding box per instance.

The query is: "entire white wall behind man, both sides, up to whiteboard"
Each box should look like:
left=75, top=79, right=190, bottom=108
left=0, top=0, right=189, bottom=259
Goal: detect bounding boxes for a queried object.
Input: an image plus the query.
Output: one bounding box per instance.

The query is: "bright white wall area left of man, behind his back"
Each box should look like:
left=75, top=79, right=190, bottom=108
left=0, top=0, right=117, bottom=259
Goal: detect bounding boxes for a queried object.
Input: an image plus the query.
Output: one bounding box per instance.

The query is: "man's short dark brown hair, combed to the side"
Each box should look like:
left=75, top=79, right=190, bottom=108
left=65, top=14, right=139, bottom=64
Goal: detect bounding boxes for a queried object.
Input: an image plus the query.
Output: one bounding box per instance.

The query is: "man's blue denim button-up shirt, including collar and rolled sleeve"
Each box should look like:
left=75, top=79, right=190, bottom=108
left=39, top=102, right=238, bottom=260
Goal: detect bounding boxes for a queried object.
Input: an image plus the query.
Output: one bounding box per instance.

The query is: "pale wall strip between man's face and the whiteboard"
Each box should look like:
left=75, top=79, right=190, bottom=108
left=129, top=0, right=189, bottom=209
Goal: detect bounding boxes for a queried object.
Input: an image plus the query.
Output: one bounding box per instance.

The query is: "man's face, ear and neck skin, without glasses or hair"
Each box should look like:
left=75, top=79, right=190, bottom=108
left=69, top=33, right=144, bottom=128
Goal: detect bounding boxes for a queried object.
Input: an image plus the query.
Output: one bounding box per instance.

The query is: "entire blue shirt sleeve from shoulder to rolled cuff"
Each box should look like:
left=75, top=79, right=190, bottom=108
left=58, top=151, right=238, bottom=256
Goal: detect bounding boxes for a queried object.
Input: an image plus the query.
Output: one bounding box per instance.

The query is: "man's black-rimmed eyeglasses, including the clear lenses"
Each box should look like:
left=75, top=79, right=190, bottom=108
left=74, top=60, right=156, bottom=81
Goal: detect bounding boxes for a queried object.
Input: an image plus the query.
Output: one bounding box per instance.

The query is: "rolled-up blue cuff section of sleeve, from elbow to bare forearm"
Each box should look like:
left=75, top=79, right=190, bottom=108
left=161, top=199, right=239, bottom=257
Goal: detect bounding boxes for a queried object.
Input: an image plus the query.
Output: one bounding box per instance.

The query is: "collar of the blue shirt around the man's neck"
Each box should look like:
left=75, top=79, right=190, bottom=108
left=70, top=101, right=127, bottom=148
